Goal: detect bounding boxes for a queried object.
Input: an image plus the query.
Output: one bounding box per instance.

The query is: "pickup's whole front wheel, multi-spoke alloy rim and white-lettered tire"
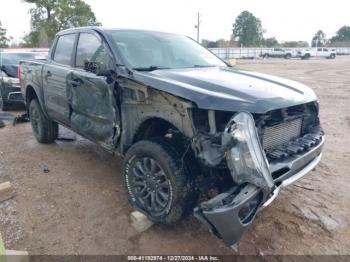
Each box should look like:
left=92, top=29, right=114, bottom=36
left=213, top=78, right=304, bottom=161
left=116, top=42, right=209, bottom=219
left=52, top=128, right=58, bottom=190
left=124, top=138, right=197, bottom=225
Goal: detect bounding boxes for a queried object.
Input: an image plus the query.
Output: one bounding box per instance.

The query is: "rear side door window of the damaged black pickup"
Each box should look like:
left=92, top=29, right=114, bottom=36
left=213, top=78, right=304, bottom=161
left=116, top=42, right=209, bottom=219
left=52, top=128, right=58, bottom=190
left=53, top=34, right=76, bottom=65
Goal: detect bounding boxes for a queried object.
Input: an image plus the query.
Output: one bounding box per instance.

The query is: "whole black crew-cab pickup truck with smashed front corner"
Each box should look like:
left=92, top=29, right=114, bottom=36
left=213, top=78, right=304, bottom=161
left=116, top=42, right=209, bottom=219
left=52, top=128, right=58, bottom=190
left=20, top=27, right=324, bottom=249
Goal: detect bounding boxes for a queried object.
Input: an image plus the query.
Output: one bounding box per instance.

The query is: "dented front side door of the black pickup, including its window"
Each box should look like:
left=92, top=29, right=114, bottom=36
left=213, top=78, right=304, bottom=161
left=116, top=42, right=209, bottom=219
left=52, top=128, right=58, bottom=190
left=67, top=32, right=120, bottom=151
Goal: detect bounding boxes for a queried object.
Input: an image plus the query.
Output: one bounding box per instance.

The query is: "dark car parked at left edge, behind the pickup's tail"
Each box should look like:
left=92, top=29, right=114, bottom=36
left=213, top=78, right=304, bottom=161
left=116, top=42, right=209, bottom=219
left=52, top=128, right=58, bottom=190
left=0, top=50, right=47, bottom=111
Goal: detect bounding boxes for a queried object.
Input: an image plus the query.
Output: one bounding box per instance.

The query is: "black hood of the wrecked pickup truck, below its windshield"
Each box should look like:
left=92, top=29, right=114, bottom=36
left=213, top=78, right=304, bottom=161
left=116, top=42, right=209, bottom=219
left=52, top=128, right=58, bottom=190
left=134, top=67, right=317, bottom=113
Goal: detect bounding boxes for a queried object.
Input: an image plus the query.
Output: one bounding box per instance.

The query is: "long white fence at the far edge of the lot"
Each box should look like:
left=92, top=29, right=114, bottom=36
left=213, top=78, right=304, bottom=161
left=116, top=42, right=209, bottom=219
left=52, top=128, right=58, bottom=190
left=210, top=47, right=350, bottom=60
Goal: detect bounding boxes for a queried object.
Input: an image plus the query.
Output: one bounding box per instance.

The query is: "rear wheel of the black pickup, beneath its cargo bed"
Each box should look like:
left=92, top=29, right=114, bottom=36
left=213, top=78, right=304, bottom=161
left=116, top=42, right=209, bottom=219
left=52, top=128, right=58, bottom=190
left=29, top=99, right=58, bottom=144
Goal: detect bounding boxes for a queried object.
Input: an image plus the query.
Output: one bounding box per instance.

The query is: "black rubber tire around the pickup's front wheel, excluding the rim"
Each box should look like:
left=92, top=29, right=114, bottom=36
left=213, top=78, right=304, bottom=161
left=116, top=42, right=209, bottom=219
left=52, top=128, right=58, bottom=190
left=123, top=138, right=198, bottom=225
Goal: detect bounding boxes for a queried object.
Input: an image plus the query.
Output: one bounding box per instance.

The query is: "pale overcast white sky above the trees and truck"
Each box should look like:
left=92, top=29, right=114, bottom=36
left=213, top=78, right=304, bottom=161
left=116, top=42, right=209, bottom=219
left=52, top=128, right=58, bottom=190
left=0, top=0, right=350, bottom=41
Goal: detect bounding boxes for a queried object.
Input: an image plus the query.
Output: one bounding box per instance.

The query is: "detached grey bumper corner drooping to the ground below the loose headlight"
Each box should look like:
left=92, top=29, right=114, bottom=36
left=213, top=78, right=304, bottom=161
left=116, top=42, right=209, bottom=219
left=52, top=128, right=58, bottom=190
left=194, top=184, right=263, bottom=246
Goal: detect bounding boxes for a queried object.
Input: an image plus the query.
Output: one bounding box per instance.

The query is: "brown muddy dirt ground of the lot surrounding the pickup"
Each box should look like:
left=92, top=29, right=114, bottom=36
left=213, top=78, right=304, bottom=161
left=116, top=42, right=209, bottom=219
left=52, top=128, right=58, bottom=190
left=0, top=57, right=350, bottom=254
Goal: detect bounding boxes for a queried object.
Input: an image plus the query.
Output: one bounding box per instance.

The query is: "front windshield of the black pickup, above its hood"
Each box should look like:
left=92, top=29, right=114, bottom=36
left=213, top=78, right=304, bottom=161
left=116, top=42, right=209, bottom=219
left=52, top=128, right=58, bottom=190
left=109, top=30, right=226, bottom=71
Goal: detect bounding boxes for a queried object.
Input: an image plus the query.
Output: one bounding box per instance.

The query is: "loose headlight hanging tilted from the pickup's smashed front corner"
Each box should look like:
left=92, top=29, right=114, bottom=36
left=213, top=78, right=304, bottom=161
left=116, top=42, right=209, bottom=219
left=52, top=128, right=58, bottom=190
left=223, top=112, right=274, bottom=191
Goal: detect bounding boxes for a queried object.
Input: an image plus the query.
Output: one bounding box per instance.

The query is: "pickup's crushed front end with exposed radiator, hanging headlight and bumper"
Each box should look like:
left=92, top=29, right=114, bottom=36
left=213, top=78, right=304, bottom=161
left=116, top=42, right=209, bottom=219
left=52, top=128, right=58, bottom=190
left=192, top=102, right=324, bottom=246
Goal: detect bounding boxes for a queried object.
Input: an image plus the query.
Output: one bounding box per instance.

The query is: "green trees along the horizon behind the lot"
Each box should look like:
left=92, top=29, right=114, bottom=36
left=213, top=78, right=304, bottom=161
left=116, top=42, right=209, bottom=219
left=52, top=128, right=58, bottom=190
left=0, top=3, right=350, bottom=48
